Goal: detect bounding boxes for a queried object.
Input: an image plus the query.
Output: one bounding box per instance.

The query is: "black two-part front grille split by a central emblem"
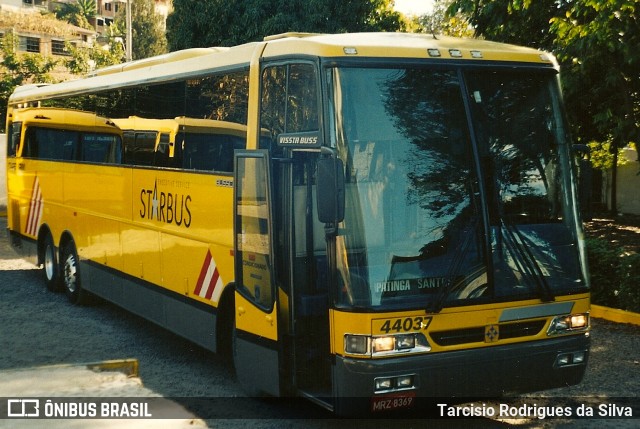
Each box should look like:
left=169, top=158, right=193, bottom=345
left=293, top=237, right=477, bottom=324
left=430, top=320, right=547, bottom=346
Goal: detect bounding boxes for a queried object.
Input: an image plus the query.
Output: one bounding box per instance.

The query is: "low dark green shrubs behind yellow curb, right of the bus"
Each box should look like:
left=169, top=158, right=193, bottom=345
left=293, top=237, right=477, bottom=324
left=587, top=238, right=640, bottom=312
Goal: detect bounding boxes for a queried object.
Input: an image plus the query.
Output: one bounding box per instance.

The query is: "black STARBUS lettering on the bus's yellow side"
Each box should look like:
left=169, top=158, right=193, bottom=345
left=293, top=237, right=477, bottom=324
left=139, top=180, right=192, bottom=228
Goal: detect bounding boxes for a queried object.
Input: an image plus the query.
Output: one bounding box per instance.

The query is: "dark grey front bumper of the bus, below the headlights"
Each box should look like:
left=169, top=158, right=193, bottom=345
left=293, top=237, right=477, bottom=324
left=334, top=334, right=590, bottom=414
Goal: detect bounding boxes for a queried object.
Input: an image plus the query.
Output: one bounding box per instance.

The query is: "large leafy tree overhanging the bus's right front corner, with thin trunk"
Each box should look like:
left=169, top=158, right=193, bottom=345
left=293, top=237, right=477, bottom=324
left=449, top=0, right=640, bottom=211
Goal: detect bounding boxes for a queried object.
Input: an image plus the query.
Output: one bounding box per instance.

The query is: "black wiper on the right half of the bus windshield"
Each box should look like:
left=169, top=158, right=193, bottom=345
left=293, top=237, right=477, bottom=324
left=499, top=216, right=555, bottom=302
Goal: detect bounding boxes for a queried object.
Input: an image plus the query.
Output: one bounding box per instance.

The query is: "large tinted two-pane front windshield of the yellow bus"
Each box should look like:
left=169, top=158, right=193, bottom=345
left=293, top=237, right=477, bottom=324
left=330, top=67, right=586, bottom=311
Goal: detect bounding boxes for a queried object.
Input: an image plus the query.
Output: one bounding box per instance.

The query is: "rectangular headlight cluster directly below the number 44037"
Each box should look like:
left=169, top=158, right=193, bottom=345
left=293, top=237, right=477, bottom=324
left=344, top=333, right=431, bottom=356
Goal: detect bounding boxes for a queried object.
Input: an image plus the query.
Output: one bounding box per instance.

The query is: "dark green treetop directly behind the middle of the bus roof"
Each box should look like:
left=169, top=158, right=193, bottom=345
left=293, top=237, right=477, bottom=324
left=167, top=0, right=406, bottom=51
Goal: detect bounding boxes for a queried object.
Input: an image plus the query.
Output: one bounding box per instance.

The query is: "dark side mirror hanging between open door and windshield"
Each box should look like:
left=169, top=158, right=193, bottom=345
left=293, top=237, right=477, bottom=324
left=316, top=156, right=344, bottom=224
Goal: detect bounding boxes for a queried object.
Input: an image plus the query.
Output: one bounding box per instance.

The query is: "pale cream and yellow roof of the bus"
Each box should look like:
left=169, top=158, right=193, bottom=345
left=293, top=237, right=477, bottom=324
left=9, top=33, right=558, bottom=104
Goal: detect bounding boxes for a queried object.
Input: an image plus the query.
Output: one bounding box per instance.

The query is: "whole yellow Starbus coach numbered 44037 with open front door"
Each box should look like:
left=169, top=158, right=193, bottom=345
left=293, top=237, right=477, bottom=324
left=7, top=33, right=590, bottom=414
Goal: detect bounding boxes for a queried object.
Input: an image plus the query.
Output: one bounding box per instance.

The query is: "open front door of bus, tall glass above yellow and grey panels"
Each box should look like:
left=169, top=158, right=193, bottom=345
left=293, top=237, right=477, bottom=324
left=233, top=150, right=280, bottom=396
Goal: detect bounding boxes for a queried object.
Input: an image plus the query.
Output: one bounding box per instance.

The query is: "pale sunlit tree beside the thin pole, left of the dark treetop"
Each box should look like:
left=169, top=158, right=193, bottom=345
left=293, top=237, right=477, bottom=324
left=113, top=0, right=168, bottom=60
